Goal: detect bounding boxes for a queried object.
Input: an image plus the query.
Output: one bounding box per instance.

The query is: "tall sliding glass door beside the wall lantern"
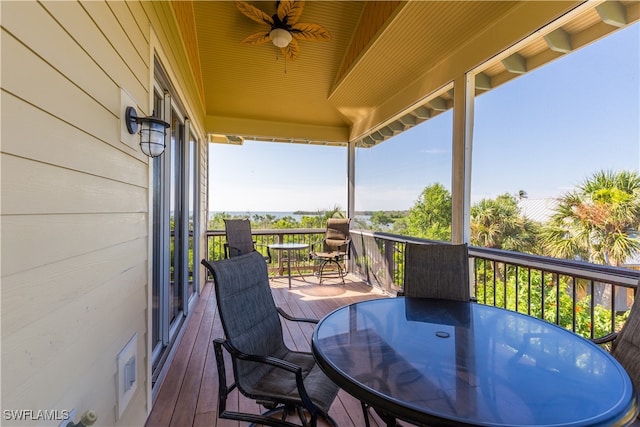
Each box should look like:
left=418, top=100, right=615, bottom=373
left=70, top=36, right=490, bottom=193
left=151, top=72, right=199, bottom=383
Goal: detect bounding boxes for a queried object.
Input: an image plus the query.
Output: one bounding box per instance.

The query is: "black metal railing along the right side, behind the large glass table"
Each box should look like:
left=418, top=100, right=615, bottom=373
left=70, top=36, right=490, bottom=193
left=350, top=230, right=640, bottom=338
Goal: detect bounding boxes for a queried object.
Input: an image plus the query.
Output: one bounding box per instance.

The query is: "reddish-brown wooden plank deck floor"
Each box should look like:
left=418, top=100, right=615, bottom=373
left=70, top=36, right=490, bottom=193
left=146, top=276, right=384, bottom=427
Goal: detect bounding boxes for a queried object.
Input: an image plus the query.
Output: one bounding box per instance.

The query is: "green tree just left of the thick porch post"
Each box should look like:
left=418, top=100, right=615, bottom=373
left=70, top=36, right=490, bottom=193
left=406, top=183, right=451, bottom=241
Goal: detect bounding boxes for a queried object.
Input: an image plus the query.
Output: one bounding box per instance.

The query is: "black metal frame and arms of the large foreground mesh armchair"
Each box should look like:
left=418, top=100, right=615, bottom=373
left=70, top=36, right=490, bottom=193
left=201, top=253, right=337, bottom=427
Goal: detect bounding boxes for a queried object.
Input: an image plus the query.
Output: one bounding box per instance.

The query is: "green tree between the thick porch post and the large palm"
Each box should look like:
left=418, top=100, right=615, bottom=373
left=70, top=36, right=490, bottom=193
left=470, top=192, right=539, bottom=252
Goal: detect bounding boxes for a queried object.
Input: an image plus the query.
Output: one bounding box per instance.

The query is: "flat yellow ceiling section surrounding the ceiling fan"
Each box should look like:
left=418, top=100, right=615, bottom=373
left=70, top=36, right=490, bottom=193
left=194, top=1, right=364, bottom=144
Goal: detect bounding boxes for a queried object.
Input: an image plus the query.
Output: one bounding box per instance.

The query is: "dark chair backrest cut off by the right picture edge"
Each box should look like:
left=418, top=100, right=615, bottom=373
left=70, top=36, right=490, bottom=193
left=611, top=293, right=640, bottom=393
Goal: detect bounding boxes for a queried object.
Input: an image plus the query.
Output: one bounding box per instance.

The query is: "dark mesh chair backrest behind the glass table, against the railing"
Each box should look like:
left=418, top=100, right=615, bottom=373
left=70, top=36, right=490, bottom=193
left=404, top=242, right=470, bottom=301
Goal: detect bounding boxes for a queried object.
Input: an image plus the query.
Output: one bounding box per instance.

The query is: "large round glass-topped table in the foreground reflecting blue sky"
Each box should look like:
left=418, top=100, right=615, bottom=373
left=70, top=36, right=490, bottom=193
left=312, top=297, right=638, bottom=427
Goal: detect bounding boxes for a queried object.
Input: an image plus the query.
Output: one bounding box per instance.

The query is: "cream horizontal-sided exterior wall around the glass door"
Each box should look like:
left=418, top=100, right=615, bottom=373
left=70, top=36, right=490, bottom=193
left=0, top=1, right=206, bottom=426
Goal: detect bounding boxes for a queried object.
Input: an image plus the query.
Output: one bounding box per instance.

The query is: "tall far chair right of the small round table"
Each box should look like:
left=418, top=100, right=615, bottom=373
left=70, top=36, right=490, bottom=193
left=309, top=218, right=351, bottom=285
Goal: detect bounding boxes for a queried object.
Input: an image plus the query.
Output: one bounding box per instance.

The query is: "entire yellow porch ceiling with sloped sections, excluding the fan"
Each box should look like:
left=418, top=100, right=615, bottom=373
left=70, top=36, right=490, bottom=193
left=173, top=1, right=637, bottom=146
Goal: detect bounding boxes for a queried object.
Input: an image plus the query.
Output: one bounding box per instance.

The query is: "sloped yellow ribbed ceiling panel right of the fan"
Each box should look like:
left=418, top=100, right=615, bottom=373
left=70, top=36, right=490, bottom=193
left=330, top=1, right=518, bottom=122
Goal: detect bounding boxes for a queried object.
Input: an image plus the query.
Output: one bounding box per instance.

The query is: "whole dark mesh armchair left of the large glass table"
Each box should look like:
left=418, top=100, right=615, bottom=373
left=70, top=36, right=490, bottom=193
left=202, top=251, right=338, bottom=426
